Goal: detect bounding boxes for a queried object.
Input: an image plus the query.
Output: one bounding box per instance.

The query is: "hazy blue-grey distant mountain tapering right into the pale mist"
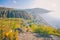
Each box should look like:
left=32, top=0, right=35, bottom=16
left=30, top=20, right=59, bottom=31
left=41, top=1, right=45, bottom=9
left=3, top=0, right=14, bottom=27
left=26, top=8, right=50, bottom=14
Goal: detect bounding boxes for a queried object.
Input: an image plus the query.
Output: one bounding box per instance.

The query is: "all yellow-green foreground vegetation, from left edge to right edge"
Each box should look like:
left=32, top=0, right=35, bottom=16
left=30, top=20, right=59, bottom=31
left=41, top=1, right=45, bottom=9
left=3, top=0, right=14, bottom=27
left=0, top=18, right=60, bottom=40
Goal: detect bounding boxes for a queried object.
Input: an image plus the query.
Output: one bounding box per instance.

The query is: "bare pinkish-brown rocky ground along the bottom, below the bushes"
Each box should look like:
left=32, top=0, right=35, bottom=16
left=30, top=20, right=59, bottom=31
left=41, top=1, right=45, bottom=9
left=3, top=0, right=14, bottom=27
left=19, top=32, right=60, bottom=40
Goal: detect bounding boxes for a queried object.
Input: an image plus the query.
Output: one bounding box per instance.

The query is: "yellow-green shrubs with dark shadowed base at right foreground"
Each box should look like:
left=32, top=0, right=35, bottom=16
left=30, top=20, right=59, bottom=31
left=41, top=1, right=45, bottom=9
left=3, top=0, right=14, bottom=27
left=31, top=24, right=60, bottom=37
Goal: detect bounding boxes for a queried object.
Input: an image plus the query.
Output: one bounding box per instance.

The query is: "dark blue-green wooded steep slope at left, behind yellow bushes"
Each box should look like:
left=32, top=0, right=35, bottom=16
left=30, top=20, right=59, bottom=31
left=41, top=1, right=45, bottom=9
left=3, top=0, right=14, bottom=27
left=0, top=7, right=32, bottom=19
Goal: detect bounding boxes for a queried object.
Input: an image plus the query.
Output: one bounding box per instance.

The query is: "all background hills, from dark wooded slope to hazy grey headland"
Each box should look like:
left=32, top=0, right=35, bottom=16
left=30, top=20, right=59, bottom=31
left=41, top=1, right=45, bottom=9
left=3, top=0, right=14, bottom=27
left=0, top=7, right=49, bottom=25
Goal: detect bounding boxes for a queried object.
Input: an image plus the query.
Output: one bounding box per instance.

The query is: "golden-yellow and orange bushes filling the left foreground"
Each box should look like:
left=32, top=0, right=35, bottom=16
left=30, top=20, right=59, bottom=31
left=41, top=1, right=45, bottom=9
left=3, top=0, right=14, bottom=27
left=0, top=19, right=19, bottom=40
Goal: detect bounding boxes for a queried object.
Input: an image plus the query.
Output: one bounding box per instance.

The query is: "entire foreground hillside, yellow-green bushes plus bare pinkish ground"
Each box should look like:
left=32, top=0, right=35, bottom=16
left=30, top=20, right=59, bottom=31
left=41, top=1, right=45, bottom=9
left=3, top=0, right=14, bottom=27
left=0, top=18, right=60, bottom=40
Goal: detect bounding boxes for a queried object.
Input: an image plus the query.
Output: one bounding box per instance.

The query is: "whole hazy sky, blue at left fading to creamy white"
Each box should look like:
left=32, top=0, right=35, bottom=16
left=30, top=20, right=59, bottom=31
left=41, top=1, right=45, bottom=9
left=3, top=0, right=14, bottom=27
left=0, top=0, right=60, bottom=19
